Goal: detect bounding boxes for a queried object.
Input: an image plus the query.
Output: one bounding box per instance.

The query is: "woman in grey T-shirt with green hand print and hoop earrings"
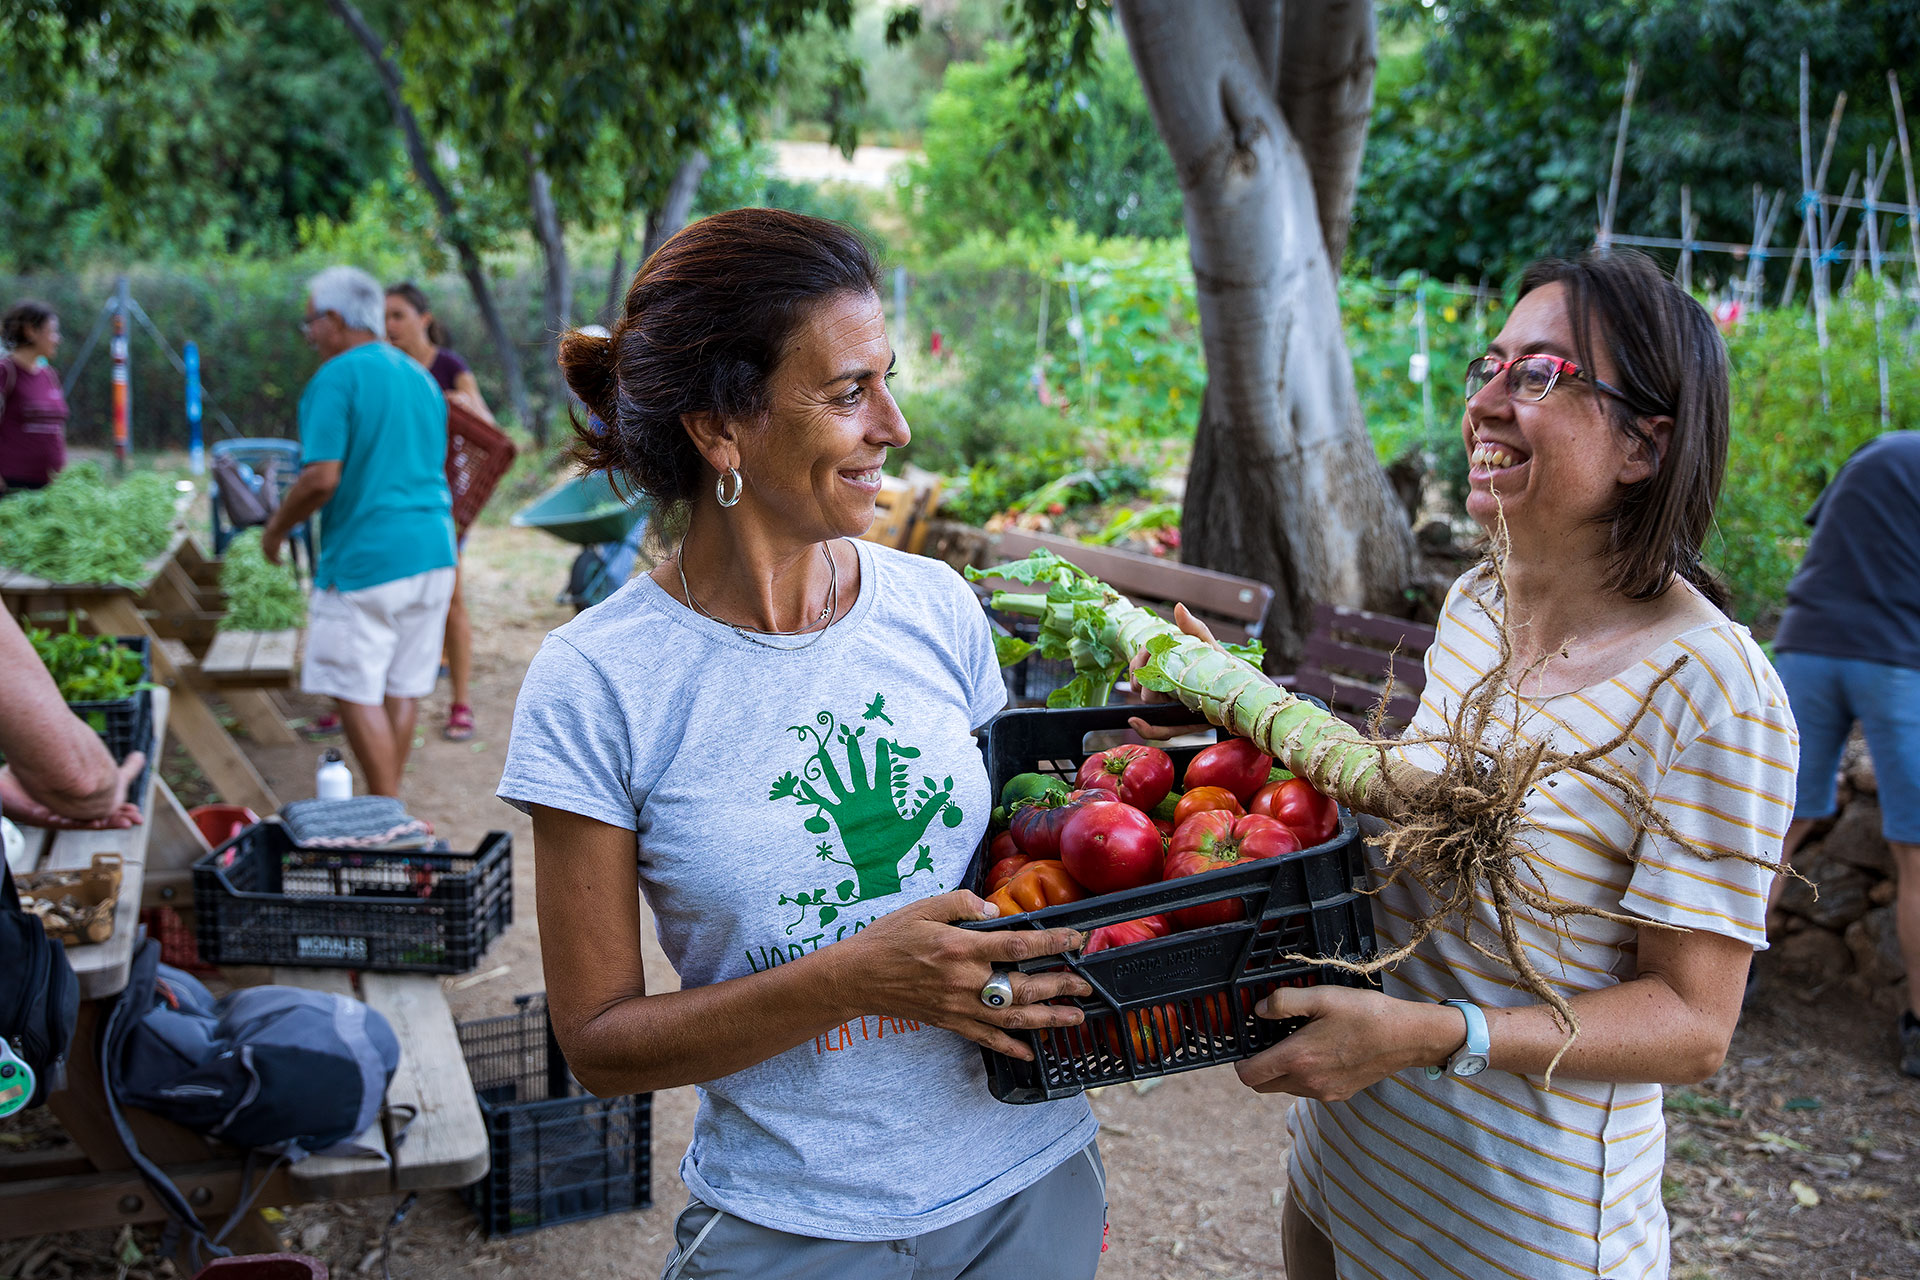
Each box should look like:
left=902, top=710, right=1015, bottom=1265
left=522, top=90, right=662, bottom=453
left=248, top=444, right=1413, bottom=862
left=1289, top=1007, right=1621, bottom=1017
left=499, top=209, right=1106, bottom=1280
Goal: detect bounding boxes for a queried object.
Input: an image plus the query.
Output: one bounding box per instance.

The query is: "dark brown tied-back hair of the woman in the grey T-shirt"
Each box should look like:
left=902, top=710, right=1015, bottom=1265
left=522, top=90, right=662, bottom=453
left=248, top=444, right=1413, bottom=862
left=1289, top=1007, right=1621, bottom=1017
left=561, top=209, right=879, bottom=505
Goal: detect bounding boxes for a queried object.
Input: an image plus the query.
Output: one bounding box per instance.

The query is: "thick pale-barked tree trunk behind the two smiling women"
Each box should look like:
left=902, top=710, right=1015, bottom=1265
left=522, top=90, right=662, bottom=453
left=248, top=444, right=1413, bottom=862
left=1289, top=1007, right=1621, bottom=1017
left=1116, top=0, right=1413, bottom=662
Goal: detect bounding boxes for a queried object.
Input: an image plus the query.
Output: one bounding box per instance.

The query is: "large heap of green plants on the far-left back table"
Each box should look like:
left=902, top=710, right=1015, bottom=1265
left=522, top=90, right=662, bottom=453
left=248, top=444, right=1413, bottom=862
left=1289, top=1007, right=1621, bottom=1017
left=0, top=462, right=173, bottom=587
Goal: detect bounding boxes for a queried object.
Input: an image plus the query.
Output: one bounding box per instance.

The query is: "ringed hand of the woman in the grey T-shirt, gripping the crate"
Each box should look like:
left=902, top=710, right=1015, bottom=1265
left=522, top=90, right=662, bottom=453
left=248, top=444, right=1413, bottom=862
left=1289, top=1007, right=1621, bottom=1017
left=820, top=889, right=1092, bottom=1061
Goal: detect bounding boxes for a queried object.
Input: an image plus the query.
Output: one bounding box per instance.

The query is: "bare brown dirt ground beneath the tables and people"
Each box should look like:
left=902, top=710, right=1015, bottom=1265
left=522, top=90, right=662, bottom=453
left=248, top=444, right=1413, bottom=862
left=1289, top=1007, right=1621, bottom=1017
left=11, top=528, right=1920, bottom=1280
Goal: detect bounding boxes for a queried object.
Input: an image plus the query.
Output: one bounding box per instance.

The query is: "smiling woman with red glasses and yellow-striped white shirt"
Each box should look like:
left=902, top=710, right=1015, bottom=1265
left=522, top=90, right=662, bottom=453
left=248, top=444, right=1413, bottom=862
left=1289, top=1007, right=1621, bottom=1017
left=1136, top=253, right=1799, bottom=1280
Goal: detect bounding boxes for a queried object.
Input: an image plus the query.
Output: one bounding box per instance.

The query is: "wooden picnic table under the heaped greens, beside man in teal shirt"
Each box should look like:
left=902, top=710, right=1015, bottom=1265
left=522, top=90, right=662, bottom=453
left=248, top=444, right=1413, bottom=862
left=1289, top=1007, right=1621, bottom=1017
left=0, top=530, right=300, bottom=816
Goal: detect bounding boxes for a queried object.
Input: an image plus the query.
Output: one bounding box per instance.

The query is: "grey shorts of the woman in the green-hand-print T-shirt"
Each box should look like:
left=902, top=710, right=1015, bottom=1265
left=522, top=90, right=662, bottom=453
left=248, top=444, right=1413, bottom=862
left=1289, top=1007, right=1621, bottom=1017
left=660, top=1142, right=1106, bottom=1280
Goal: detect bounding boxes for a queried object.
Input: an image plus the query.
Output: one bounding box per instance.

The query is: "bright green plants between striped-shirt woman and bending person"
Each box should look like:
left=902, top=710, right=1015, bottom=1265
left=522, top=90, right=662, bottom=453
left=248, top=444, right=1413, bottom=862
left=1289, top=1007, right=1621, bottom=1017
left=1707, top=291, right=1920, bottom=624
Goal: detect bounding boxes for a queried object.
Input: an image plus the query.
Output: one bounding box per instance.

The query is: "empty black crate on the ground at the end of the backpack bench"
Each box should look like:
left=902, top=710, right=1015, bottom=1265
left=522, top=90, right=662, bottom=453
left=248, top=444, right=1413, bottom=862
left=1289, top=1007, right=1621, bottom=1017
left=459, top=994, right=653, bottom=1236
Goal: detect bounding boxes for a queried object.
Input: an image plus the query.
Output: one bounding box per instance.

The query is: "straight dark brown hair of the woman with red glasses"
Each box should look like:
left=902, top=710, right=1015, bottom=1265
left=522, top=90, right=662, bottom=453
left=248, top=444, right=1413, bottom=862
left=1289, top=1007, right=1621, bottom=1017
left=1519, top=249, right=1730, bottom=606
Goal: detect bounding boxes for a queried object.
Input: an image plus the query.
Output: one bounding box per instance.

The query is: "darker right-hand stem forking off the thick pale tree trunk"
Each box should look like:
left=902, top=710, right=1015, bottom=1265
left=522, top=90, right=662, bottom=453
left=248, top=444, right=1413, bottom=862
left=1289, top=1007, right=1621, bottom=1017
left=1274, top=0, right=1377, bottom=271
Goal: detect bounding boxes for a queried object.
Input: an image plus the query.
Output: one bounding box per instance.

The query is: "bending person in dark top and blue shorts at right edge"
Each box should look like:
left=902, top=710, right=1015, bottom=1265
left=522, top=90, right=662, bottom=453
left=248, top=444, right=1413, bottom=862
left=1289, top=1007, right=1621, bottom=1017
left=1774, top=432, right=1920, bottom=1077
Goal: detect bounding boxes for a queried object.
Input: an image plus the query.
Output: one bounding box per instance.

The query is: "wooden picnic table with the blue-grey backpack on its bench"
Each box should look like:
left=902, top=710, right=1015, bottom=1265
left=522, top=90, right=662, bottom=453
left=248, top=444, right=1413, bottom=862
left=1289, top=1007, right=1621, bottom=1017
left=0, top=689, right=488, bottom=1251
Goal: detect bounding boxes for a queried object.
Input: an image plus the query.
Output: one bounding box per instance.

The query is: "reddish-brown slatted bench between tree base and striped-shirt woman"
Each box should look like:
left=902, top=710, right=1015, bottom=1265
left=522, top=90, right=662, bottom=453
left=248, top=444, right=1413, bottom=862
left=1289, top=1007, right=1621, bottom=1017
left=1279, top=604, right=1434, bottom=731
